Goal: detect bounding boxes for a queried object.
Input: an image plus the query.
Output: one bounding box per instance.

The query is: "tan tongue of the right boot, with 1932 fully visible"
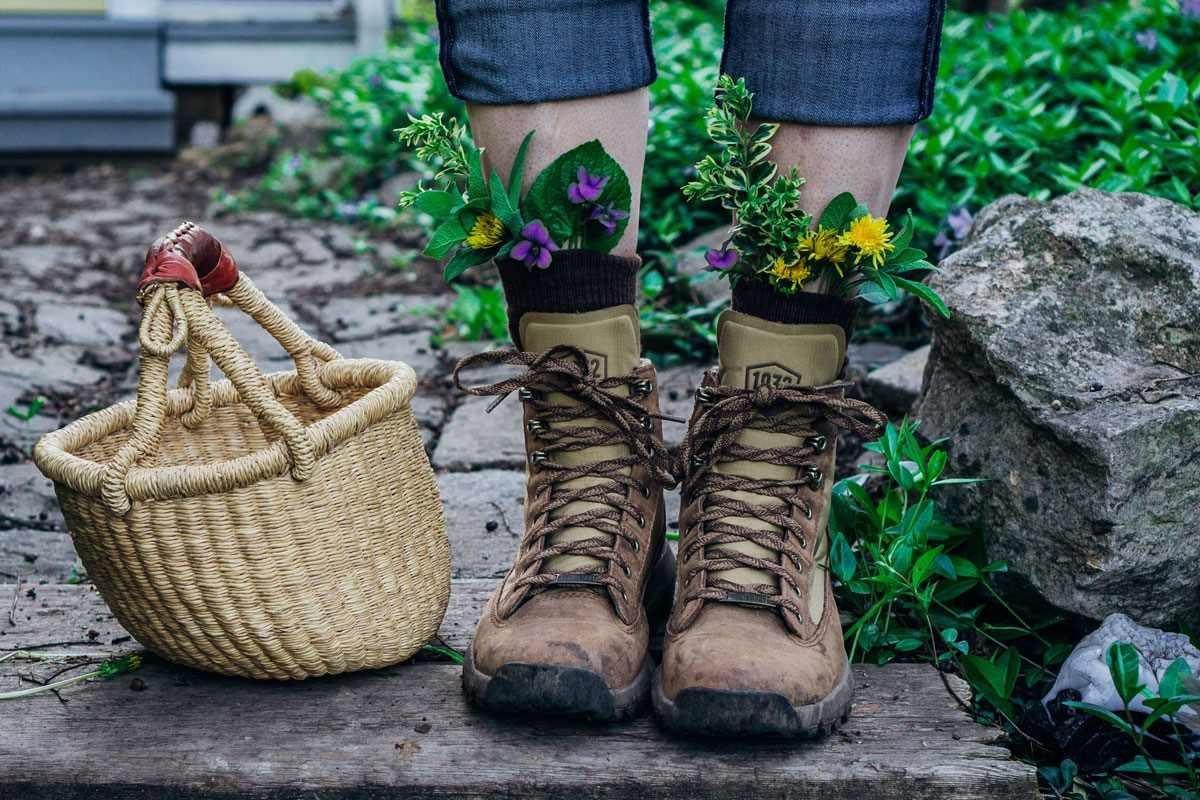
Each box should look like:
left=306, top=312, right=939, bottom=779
left=710, top=311, right=846, bottom=589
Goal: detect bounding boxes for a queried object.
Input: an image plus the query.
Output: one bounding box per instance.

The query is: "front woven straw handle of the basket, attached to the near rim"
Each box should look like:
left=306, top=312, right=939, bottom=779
left=101, top=240, right=332, bottom=516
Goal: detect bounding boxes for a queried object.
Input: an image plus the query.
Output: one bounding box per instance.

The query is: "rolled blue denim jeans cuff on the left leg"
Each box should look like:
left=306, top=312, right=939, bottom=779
left=436, top=0, right=656, bottom=104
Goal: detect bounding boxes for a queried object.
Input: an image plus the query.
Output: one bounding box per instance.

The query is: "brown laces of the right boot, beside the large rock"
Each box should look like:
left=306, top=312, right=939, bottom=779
left=676, top=383, right=888, bottom=615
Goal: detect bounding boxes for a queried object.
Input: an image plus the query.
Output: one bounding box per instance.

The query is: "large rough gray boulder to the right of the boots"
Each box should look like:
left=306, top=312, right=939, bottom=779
left=917, top=190, right=1200, bottom=626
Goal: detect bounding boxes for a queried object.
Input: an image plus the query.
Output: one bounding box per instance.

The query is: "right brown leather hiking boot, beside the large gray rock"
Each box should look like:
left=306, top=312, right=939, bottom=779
left=653, top=312, right=887, bottom=736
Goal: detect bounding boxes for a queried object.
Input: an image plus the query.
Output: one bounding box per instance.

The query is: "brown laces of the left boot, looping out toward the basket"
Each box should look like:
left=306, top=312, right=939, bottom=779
left=454, top=345, right=676, bottom=594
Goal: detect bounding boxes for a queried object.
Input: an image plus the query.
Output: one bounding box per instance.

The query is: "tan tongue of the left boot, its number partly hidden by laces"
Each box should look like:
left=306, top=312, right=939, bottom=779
left=518, top=306, right=642, bottom=572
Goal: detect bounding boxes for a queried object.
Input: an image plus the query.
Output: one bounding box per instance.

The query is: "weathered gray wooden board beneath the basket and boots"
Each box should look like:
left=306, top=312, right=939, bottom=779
left=0, top=581, right=1037, bottom=800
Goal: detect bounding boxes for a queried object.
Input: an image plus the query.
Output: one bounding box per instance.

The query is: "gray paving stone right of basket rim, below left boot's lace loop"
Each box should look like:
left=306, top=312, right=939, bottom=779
left=433, top=393, right=524, bottom=470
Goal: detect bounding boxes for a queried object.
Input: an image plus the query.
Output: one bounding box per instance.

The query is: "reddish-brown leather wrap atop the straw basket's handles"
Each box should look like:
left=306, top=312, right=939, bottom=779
left=138, top=222, right=238, bottom=296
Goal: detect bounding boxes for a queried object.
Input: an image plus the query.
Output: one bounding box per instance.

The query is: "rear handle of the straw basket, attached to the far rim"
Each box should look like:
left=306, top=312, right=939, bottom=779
left=146, top=222, right=342, bottom=417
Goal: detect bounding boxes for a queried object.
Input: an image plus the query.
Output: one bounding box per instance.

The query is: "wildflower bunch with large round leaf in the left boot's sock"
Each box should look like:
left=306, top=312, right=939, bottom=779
left=400, top=113, right=632, bottom=282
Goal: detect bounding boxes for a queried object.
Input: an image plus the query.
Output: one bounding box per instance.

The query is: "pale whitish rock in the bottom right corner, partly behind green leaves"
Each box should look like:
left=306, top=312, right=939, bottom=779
left=1042, top=614, right=1200, bottom=721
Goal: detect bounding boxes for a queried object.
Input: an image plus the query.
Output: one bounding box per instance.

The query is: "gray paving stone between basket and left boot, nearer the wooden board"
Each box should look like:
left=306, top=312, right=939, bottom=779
left=438, top=469, right=524, bottom=578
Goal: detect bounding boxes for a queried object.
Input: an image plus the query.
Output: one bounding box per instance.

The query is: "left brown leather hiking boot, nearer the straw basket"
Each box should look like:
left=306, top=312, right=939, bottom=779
left=455, top=306, right=674, bottom=721
